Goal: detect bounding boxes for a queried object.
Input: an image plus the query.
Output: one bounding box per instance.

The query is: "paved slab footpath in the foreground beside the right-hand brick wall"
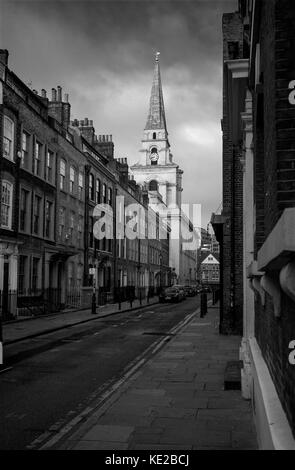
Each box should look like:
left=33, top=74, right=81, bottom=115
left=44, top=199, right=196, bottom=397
left=49, top=307, right=257, bottom=450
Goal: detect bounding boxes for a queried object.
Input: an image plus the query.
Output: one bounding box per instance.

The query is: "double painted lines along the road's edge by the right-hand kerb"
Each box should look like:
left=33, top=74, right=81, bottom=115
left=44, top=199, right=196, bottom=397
left=26, top=308, right=200, bottom=450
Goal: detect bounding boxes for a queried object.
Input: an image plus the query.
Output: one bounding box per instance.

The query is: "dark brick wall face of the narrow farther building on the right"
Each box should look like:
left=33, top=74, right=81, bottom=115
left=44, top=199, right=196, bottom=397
left=218, top=12, right=248, bottom=334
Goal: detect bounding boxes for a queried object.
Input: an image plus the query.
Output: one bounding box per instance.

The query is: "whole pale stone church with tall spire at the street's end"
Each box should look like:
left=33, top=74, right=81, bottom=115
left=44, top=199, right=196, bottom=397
left=131, top=53, right=199, bottom=284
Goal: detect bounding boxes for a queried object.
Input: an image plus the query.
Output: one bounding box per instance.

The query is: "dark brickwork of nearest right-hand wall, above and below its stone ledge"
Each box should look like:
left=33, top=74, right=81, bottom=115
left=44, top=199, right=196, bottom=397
left=251, top=0, right=295, bottom=436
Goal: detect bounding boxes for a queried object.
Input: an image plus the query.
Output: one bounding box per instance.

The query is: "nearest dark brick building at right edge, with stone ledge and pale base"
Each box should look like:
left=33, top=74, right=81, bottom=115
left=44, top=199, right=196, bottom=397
left=245, top=0, right=295, bottom=450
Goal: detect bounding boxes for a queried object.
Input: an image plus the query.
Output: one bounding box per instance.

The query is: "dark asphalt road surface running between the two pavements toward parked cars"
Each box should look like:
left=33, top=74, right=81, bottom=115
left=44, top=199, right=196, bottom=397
left=0, top=297, right=199, bottom=450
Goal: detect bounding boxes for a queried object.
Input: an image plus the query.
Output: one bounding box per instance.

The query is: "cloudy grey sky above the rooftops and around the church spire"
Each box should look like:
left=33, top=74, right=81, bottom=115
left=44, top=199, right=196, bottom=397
left=0, top=0, right=237, bottom=226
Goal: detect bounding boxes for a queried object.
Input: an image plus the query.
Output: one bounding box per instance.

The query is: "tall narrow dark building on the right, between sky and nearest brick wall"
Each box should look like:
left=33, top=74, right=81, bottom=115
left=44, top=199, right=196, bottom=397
left=211, top=4, right=249, bottom=334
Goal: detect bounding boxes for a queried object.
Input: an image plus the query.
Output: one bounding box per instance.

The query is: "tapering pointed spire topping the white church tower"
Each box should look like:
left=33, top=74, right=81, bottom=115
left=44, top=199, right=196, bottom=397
left=145, top=52, right=167, bottom=132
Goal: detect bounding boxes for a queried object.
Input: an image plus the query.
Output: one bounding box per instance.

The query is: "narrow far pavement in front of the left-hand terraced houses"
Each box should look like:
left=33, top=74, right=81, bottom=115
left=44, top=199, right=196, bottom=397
left=3, top=296, right=158, bottom=345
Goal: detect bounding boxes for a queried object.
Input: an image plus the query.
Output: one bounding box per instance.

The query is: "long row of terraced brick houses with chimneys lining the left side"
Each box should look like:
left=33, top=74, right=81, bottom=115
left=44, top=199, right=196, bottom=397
left=0, top=50, right=169, bottom=318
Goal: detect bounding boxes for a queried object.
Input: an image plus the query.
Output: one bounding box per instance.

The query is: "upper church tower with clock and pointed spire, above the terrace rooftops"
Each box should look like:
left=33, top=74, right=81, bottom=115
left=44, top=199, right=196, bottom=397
left=131, top=52, right=183, bottom=207
